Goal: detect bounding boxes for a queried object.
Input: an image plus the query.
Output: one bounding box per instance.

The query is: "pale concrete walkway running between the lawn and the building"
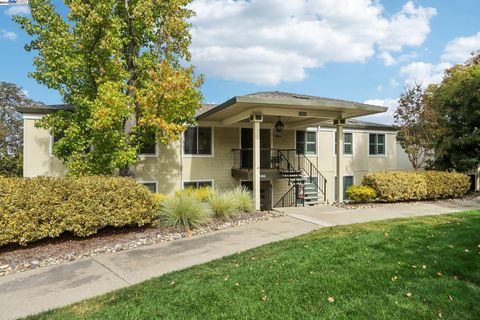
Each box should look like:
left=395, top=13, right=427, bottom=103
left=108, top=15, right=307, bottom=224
left=0, top=200, right=480, bottom=319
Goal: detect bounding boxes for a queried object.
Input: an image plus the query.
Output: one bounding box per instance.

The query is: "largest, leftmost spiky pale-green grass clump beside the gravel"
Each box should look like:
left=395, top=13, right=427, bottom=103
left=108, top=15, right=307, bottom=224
left=158, top=193, right=212, bottom=228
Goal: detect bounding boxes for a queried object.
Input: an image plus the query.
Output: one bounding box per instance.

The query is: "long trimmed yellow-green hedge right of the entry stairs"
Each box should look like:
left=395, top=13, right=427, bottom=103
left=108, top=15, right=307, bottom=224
left=362, top=171, right=470, bottom=202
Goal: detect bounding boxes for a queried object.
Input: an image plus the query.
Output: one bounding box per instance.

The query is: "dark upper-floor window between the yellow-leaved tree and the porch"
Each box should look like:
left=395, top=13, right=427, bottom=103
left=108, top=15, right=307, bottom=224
left=183, top=127, right=212, bottom=155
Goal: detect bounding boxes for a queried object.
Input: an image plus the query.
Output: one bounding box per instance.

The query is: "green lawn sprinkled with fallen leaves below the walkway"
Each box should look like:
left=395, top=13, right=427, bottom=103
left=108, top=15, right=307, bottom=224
left=29, top=209, right=480, bottom=320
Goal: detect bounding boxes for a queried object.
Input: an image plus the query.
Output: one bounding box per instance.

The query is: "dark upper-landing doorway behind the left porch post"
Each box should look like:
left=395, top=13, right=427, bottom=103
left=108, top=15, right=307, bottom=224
left=240, top=128, right=270, bottom=169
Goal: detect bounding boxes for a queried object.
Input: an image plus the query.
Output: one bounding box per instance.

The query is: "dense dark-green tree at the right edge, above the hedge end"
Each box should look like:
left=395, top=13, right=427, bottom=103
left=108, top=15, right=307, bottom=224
left=428, top=51, right=480, bottom=172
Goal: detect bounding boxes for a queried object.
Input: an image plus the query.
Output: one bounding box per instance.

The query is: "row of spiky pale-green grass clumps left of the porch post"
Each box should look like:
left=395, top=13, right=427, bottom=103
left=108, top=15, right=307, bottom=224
left=156, top=187, right=253, bottom=228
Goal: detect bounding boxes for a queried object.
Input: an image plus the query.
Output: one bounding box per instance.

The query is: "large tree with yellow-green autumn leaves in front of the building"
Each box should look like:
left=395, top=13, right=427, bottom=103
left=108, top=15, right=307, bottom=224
left=14, top=0, right=202, bottom=175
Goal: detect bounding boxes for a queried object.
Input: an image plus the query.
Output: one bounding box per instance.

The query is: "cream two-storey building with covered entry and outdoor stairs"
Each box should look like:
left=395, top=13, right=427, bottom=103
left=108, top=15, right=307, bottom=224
left=18, top=92, right=412, bottom=210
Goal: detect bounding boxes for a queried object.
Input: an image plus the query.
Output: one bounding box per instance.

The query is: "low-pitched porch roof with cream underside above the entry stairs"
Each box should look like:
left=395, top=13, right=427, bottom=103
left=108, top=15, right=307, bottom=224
left=197, top=92, right=387, bottom=127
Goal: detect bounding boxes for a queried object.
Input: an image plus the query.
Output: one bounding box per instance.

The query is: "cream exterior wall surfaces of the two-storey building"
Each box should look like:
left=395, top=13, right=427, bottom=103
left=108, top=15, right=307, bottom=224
left=24, top=115, right=412, bottom=205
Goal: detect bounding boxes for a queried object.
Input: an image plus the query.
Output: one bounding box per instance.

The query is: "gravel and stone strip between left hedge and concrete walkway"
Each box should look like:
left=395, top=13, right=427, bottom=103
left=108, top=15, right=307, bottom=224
left=0, top=211, right=284, bottom=276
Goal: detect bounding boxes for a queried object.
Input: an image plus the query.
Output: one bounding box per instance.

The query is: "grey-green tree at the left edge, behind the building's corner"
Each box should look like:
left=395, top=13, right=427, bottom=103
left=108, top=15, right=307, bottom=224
left=0, top=82, right=34, bottom=176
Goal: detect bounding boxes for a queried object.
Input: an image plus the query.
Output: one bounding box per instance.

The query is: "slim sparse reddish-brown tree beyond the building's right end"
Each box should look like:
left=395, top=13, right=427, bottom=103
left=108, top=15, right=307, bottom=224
left=394, top=83, right=437, bottom=170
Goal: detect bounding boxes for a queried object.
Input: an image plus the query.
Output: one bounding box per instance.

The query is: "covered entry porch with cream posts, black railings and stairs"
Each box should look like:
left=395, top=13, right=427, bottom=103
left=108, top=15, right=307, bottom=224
left=197, top=92, right=387, bottom=210
